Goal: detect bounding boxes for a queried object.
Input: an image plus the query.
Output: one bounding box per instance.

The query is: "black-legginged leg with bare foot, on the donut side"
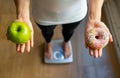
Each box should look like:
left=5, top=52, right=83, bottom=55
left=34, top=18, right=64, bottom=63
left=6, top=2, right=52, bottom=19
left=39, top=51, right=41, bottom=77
left=62, top=21, right=80, bottom=58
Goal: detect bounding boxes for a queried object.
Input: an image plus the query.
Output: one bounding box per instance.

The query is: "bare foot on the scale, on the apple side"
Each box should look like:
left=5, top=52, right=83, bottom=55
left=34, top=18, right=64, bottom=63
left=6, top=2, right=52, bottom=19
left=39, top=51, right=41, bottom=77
left=45, top=42, right=53, bottom=59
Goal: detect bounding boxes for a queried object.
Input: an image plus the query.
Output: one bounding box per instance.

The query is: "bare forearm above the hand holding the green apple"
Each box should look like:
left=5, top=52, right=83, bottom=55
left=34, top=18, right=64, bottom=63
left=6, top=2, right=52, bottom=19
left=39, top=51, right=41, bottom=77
left=14, top=0, right=30, bottom=19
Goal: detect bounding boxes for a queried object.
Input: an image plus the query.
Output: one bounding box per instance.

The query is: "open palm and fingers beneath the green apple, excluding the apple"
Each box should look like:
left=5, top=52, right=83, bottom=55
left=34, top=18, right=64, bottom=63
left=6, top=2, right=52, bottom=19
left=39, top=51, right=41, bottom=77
left=15, top=19, right=34, bottom=53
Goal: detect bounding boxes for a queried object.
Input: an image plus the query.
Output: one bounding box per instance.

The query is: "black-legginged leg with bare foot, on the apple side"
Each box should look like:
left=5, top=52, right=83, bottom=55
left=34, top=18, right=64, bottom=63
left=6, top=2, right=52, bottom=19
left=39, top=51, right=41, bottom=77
left=38, top=25, right=56, bottom=59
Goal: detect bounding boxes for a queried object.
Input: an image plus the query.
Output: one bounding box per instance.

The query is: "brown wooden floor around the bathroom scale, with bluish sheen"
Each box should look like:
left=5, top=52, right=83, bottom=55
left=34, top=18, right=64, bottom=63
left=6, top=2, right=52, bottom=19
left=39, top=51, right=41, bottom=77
left=0, top=0, right=120, bottom=78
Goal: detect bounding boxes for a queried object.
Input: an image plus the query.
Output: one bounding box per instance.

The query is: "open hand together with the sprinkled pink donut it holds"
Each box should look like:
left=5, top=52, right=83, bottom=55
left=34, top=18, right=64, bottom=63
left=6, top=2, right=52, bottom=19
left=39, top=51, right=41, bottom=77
left=85, top=21, right=113, bottom=58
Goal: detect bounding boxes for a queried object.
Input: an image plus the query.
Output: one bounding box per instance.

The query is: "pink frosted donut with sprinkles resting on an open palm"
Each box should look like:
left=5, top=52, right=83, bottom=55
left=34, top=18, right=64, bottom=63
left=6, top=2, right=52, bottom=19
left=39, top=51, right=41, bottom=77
left=87, top=27, right=109, bottom=49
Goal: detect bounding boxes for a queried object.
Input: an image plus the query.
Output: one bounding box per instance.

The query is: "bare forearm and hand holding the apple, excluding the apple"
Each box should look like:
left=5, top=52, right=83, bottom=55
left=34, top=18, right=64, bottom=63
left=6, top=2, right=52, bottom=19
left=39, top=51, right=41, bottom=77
left=11, top=0, right=34, bottom=53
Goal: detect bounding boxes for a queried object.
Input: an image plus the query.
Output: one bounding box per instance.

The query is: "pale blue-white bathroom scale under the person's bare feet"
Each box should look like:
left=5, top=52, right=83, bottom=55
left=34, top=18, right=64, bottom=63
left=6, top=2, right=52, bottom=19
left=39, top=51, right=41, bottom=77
left=44, top=40, right=73, bottom=64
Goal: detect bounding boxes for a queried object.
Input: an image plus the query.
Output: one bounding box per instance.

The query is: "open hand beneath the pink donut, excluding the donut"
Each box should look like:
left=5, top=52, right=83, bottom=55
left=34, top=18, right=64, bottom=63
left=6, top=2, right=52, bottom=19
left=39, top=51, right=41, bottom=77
left=85, top=20, right=113, bottom=58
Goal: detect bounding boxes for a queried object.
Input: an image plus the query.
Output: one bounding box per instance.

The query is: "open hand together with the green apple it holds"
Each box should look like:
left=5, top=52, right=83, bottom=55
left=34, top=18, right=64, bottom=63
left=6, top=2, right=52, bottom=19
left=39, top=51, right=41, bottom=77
left=7, top=19, right=34, bottom=53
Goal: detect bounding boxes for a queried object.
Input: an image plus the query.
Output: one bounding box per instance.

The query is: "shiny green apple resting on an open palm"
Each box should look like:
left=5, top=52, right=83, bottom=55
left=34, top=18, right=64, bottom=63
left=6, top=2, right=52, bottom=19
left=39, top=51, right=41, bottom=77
left=7, top=21, right=31, bottom=44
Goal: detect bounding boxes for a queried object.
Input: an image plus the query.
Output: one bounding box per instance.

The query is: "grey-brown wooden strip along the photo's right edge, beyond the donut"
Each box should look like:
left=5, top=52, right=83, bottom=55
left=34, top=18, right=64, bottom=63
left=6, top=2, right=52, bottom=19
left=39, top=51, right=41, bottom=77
left=103, top=0, right=120, bottom=64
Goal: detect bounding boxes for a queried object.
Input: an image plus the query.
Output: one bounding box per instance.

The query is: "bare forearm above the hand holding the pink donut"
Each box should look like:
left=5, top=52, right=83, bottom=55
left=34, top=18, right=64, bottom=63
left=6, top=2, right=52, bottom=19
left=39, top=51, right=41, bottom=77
left=88, top=0, right=104, bottom=21
